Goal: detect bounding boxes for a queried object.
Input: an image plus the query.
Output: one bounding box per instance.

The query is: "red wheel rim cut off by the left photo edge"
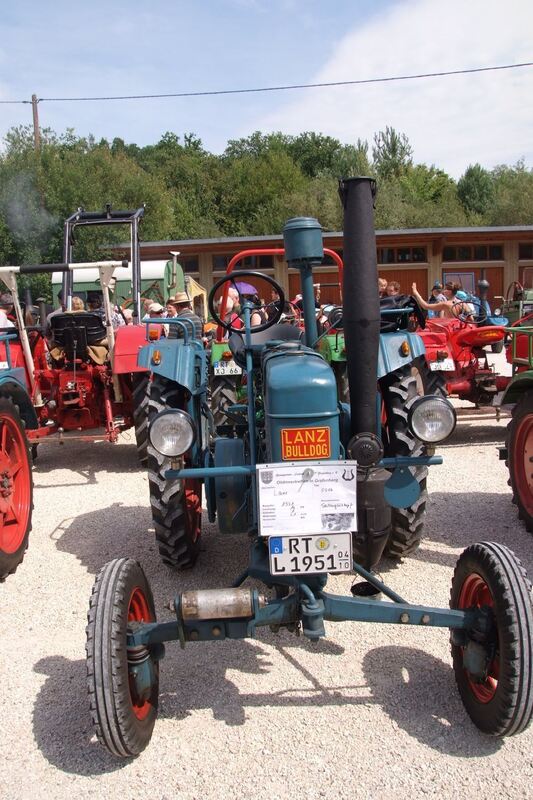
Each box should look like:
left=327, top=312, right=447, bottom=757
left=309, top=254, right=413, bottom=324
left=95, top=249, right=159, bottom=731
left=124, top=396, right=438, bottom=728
left=0, top=416, right=31, bottom=553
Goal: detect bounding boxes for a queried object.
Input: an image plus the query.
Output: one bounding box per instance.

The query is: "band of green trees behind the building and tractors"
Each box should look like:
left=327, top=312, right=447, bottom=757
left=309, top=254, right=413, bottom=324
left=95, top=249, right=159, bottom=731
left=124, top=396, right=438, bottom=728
left=0, top=126, right=533, bottom=298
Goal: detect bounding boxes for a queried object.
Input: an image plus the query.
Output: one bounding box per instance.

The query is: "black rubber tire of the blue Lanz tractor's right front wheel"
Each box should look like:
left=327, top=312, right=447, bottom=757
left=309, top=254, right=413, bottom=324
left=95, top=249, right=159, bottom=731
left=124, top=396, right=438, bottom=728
left=450, top=542, right=533, bottom=737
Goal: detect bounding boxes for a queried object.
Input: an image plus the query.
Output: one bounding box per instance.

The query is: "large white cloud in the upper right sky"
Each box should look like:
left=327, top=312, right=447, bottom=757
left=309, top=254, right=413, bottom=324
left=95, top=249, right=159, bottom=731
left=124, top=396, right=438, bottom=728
left=254, top=0, right=533, bottom=177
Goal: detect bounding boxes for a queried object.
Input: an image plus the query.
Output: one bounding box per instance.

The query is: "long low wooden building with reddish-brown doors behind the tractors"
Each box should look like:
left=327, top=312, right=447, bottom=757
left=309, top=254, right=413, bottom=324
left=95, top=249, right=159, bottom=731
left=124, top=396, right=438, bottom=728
left=134, top=225, right=533, bottom=302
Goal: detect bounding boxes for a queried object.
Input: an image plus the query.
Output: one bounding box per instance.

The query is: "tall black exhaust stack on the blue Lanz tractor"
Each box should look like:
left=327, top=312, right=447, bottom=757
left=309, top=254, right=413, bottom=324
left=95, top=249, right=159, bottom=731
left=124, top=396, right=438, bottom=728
left=339, top=177, right=391, bottom=569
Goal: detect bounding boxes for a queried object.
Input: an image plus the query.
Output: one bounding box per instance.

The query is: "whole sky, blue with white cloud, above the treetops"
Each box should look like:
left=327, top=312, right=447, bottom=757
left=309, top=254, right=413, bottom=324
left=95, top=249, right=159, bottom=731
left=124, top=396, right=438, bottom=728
left=0, top=0, right=533, bottom=177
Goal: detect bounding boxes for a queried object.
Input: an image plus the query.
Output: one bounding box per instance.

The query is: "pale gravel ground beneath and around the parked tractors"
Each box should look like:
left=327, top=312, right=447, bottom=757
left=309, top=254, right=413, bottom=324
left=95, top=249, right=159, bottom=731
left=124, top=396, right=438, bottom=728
left=0, top=378, right=533, bottom=800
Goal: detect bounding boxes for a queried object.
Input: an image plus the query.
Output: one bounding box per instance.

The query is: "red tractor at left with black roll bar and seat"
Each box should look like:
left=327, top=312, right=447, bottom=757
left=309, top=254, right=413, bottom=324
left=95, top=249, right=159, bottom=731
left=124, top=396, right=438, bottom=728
left=0, top=207, right=152, bottom=462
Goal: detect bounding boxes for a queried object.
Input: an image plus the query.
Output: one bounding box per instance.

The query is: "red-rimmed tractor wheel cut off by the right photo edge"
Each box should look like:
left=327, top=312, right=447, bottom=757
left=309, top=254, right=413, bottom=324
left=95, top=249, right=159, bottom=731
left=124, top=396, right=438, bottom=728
left=505, top=391, right=533, bottom=533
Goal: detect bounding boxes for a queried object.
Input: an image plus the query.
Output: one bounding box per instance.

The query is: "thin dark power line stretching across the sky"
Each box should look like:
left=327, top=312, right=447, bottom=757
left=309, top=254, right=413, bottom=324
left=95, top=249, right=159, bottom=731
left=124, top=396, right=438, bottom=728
left=0, top=61, right=533, bottom=104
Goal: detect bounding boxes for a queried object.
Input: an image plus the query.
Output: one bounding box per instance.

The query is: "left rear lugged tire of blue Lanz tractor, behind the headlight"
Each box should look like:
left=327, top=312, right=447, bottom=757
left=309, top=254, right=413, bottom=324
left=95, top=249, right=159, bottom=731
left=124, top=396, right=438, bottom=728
left=148, top=375, right=202, bottom=569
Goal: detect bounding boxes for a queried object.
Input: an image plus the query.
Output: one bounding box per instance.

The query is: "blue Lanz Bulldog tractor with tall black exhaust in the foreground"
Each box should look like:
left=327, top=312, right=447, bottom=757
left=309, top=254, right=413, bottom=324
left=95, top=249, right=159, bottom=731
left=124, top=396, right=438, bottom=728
left=87, top=178, right=533, bottom=758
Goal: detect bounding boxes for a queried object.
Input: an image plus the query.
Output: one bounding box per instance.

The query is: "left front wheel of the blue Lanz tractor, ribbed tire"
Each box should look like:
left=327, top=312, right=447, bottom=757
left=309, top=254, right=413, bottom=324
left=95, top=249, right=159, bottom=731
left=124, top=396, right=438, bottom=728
left=85, top=558, right=159, bottom=758
